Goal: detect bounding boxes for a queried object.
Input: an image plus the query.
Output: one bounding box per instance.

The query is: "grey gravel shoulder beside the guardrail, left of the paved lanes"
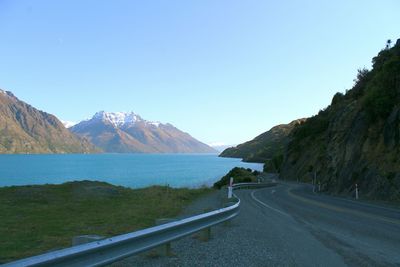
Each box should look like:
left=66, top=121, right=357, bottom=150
left=113, top=187, right=345, bottom=266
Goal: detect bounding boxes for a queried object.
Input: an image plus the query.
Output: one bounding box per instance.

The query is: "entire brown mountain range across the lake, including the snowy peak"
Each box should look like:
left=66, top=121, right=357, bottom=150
left=0, top=89, right=217, bottom=154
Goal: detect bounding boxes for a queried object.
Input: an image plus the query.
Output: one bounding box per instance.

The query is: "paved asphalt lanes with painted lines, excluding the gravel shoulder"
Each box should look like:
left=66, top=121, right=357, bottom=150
left=250, top=184, right=400, bottom=266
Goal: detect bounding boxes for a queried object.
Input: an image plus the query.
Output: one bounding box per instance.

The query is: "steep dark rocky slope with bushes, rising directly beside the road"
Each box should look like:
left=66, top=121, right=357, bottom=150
left=281, top=40, right=400, bottom=200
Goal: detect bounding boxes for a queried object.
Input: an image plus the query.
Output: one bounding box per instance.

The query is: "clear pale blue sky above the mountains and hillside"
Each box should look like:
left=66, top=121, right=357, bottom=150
left=0, top=0, right=400, bottom=147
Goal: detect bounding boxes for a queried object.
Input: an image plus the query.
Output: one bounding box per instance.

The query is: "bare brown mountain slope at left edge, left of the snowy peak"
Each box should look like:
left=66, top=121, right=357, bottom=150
left=0, top=90, right=98, bottom=154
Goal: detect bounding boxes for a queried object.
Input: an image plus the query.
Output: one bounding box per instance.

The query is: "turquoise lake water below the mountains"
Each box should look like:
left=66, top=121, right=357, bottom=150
left=0, top=154, right=262, bottom=188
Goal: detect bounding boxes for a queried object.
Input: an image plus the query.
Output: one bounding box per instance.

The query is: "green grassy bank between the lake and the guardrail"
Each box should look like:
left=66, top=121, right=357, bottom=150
left=0, top=181, right=212, bottom=264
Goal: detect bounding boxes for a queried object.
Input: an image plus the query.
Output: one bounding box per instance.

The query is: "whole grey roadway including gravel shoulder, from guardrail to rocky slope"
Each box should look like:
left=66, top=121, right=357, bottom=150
left=112, top=183, right=400, bottom=266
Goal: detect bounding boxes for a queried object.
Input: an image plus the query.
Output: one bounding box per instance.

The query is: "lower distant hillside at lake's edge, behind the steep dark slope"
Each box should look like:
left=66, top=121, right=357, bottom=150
left=220, top=120, right=303, bottom=163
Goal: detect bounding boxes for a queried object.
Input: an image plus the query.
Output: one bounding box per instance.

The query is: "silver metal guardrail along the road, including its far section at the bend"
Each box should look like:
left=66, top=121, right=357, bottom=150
left=2, top=183, right=275, bottom=267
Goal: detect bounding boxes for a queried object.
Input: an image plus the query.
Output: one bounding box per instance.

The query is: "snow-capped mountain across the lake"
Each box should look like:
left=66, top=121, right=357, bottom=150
left=70, top=111, right=216, bottom=153
